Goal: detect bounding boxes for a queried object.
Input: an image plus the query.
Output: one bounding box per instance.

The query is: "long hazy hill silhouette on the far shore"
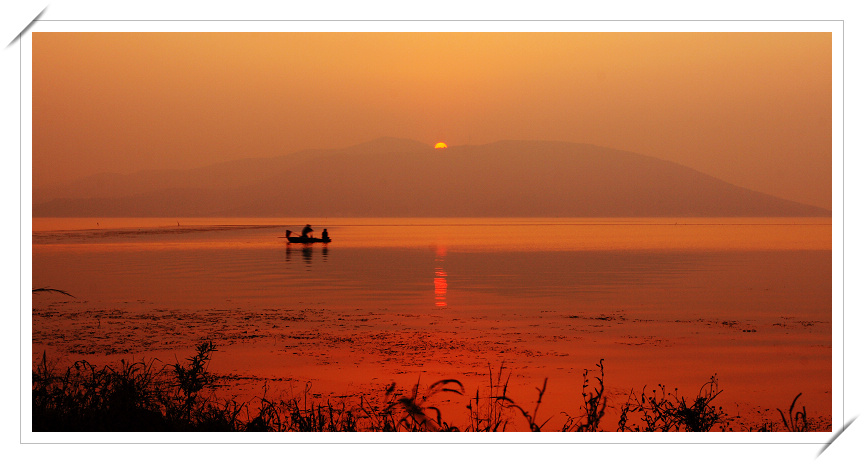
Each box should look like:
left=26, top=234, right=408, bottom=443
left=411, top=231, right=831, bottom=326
left=33, top=138, right=831, bottom=217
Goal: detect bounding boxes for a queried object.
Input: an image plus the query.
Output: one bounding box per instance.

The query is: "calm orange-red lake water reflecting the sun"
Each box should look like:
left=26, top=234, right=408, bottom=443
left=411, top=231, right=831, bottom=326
left=32, top=218, right=832, bottom=430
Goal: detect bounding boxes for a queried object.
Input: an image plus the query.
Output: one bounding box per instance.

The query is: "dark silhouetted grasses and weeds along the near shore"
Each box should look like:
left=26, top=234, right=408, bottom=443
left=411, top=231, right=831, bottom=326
left=32, top=342, right=813, bottom=432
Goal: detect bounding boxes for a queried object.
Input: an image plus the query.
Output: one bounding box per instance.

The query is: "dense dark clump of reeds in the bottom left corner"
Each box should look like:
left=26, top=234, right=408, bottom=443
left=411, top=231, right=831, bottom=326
left=32, top=342, right=236, bottom=432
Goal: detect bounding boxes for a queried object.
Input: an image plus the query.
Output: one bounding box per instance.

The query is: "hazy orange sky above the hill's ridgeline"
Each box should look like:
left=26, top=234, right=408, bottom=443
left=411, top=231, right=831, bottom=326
left=33, top=32, right=832, bottom=208
